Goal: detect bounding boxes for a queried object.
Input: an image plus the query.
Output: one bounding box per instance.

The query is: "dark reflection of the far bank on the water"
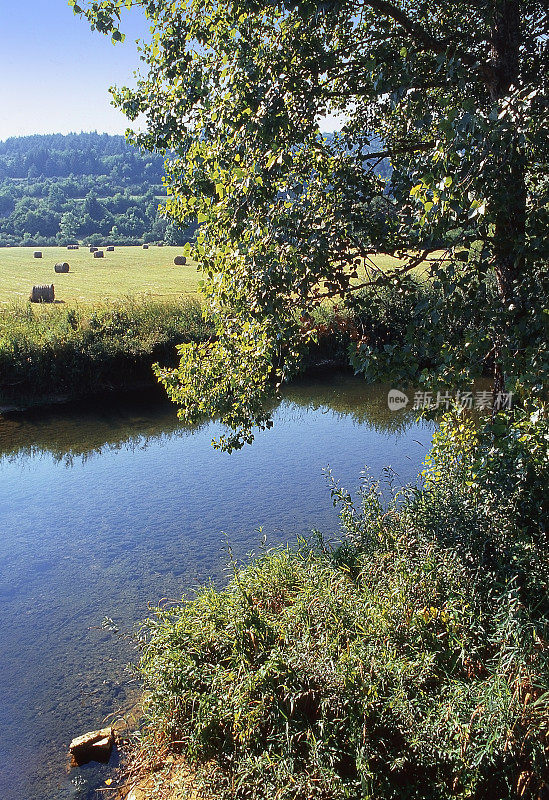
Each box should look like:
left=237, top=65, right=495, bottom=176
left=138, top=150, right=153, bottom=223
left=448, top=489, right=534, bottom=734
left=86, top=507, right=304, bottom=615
left=0, top=373, right=417, bottom=466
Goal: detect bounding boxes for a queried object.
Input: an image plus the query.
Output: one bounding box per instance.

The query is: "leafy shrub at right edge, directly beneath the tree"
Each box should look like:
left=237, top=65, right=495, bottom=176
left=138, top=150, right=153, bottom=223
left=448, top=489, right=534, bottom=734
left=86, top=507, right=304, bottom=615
left=411, top=401, right=549, bottom=620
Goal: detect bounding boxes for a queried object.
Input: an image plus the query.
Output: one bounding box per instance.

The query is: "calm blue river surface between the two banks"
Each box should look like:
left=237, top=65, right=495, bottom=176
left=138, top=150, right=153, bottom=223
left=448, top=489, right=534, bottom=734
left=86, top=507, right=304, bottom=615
left=0, top=376, right=433, bottom=800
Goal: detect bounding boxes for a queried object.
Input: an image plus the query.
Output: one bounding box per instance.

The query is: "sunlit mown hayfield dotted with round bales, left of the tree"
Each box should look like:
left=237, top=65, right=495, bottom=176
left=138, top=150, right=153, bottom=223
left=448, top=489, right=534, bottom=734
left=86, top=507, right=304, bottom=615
left=0, top=245, right=199, bottom=305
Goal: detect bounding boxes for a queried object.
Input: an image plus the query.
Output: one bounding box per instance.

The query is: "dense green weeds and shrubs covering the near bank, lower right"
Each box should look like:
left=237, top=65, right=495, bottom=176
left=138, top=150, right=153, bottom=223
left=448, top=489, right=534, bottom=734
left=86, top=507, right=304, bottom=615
left=130, top=408, right=549, bottom=800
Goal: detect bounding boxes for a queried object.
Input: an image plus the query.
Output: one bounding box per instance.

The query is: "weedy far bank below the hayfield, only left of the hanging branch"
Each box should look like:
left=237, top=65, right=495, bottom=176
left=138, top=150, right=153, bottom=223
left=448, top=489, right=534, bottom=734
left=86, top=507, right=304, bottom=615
left=0, top=299, right=211, bottom=404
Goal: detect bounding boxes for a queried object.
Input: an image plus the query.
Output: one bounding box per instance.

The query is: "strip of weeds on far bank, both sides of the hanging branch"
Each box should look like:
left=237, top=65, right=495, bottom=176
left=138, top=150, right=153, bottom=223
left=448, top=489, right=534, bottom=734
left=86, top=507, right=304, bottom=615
left=0, top=279, right=488, bottom=405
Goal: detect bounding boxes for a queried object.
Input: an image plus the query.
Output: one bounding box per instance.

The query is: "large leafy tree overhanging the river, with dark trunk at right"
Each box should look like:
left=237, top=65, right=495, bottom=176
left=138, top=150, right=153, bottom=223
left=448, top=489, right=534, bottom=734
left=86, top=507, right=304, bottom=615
left=74, top=0, right=549, bottom=447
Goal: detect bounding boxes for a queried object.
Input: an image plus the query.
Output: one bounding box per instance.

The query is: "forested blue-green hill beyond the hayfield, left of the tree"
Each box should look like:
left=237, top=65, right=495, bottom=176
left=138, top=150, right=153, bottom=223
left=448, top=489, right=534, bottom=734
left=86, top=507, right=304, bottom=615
left=0, top=133, right=185, bottom=246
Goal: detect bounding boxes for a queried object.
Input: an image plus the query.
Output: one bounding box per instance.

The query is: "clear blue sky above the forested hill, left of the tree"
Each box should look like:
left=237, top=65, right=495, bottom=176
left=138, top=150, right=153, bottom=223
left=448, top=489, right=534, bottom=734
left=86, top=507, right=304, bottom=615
left=0, top=0, right=148, bottom=141
